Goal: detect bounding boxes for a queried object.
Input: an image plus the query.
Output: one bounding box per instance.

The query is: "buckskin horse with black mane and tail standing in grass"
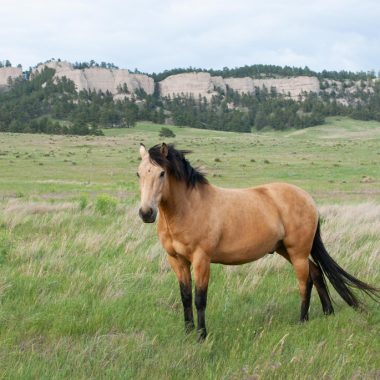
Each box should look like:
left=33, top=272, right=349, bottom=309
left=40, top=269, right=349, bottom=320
left=136, top=143, right=379, bottom=341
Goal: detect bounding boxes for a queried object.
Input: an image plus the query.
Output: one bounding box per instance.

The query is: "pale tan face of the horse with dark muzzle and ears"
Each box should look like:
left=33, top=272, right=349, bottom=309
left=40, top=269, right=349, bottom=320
left=137, top=144, right=168, bottom=223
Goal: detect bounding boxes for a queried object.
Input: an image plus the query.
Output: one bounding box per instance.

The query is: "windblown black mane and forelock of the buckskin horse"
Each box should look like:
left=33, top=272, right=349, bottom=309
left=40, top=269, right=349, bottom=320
left=148, top=144, right=208, bottom=187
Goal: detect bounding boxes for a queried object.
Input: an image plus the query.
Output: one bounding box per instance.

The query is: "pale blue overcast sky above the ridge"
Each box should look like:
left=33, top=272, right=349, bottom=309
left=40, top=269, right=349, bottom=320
left=0, top=0, right=380, bottom=73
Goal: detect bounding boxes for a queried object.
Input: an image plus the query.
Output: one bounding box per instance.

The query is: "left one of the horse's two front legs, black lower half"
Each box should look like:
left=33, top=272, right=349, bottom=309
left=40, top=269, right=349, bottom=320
left=168, top=256, right=194, bottom=332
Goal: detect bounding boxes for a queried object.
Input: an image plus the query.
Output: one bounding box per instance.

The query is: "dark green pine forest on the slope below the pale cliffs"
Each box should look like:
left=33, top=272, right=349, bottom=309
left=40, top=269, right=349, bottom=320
left=0, top=68, right=380, bottom=135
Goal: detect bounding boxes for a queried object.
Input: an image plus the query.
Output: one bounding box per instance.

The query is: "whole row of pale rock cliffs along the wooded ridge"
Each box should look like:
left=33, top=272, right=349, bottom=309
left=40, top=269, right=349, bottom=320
left=0, top=60, right=326, bottom=100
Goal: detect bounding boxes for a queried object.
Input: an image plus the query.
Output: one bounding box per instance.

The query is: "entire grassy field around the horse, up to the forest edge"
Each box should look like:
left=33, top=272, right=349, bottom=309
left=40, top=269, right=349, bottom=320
left=0, top=118, right=380, bottom=379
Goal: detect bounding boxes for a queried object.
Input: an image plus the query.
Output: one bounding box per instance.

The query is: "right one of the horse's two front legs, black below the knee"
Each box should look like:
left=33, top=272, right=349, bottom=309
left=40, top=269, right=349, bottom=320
left=192, top=251, right=210, bottom=341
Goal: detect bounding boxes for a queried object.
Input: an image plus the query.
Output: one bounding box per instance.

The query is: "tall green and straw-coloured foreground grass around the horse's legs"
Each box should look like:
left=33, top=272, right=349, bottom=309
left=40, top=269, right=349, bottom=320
left=0, top=199, right=380, bottom=379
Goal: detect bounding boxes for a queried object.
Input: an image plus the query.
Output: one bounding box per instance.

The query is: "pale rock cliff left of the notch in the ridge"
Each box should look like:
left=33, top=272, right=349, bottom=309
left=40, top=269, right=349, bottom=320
left=33, top=61, right=154, bottom=95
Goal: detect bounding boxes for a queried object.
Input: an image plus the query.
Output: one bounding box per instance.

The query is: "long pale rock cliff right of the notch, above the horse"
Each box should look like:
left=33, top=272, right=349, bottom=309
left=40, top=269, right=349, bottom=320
left=159, top=72, right=320, bottom=99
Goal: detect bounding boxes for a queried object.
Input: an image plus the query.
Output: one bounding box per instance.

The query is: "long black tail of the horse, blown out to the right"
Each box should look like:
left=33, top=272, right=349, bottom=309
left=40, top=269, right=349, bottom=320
left=311, top=221, right=380, bottom=308
